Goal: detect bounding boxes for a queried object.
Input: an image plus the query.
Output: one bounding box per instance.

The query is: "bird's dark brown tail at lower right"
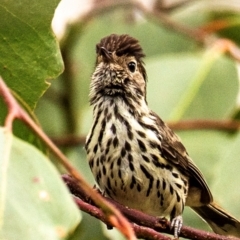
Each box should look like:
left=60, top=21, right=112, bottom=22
left=192, top=203, right=240, bottom=238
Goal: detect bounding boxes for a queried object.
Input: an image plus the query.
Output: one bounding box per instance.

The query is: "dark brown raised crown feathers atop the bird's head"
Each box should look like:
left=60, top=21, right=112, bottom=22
left=96, top=34, right=147, bottom=80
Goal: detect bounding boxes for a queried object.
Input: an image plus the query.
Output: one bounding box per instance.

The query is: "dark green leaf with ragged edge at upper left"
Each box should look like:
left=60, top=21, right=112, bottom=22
left=0, top=0, right=63, bottom=109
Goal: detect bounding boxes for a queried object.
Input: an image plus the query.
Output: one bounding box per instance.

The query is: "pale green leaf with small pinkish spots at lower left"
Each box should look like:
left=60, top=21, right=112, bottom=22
left=0, top=128, right=80, bottom=240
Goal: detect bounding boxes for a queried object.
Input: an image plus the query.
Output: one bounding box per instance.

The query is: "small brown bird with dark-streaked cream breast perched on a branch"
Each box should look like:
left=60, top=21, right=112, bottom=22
left=85, top=34, right=240, bottom=237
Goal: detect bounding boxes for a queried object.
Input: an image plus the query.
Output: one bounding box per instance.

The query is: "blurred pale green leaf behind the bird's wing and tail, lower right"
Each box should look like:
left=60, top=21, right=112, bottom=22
left=179, top=130, right=236, bottom=231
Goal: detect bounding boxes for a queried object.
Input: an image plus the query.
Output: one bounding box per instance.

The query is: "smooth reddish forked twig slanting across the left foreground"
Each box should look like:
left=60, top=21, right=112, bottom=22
left=0, top=77, right=136, bottom=240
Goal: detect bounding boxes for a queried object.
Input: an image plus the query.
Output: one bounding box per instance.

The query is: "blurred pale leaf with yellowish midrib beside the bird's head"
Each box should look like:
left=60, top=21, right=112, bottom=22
left=146, top=51, right=238, bottom=120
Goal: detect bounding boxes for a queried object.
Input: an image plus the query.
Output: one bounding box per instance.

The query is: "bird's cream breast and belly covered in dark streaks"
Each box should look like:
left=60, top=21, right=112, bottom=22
left=86, top=104, right=186, bottom=216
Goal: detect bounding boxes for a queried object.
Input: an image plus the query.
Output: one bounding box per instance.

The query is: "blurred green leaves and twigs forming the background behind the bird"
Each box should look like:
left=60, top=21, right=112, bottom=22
left=0, top=0, right=240, bottom=240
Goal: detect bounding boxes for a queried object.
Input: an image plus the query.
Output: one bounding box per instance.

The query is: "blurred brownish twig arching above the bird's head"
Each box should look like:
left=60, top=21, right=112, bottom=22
left=61, top=0, right=205, bottom=49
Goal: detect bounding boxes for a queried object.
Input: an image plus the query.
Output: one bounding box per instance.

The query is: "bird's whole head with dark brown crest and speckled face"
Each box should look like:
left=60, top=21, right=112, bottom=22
left=90, top=34, right=147, bottom=104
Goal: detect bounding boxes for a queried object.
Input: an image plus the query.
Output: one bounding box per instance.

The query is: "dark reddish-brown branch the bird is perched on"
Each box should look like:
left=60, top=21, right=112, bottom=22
left=62, top=175, right=239, bottom=240
